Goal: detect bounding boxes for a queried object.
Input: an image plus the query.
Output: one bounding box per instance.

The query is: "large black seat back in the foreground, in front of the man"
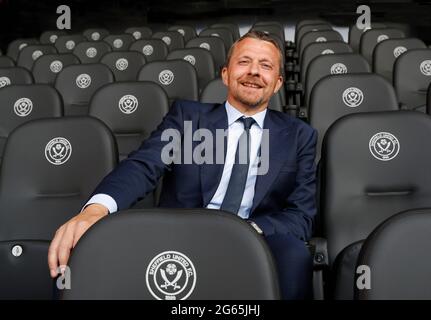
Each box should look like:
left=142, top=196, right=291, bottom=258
left=62, top=209, right=280, bottom=300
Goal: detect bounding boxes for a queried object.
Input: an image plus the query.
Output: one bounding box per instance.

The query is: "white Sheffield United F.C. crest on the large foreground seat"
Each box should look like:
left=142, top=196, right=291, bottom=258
left=145, top=251, right=196, bottom=300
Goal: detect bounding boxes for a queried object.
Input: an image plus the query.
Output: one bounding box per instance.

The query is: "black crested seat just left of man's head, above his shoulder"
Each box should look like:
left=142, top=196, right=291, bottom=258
left=138, top=60, right=199, bottom=104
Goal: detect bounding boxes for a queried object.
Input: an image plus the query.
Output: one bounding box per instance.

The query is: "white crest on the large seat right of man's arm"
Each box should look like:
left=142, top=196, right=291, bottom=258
left=369, top=132, right=400, bottom=161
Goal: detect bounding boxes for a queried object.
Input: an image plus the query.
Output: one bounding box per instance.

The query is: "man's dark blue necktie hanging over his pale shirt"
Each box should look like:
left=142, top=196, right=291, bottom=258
left=220, top=117, right=255, bottom=214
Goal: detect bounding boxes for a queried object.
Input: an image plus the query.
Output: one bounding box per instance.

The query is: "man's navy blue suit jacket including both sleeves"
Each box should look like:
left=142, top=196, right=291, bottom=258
left=93, top=101, right=317, bottom=240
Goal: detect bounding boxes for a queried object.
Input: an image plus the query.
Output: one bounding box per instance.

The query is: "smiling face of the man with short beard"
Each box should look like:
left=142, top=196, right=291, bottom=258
left=222, top=38, right=283, bottom=111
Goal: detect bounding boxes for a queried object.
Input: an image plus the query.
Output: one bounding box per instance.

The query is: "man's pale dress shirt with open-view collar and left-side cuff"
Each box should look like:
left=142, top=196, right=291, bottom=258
left=84, top=101, right=266, bottom=219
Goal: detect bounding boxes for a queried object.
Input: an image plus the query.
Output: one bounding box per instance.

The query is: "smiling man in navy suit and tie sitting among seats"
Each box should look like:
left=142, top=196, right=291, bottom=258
left=48, top=32, right=316, bottom=299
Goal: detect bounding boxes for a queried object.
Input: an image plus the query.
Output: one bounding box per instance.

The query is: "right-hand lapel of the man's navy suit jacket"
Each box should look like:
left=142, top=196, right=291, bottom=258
left=251, top=109, right=290, bottom=213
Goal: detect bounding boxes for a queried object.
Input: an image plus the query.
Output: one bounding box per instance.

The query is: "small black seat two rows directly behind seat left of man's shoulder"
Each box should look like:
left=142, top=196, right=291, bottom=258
left=100, top=51, right=146, bottom=81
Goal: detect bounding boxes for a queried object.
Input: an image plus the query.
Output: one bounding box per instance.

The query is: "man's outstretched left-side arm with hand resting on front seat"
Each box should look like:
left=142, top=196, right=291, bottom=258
left=48, top=103, right=183, bottom=277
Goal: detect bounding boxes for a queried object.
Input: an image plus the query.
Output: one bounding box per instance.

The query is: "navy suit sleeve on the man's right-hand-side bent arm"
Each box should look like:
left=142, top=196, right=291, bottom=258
left=251, top=127, right=317, bottom=241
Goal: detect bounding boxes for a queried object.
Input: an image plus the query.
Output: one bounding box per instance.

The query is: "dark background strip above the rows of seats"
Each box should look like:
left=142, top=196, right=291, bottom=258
left=0, top=0, right=431, bottom=52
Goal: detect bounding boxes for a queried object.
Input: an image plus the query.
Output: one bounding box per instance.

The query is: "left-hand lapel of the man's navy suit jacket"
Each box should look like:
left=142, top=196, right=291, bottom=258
left=199, top=103, right=228, bottom=206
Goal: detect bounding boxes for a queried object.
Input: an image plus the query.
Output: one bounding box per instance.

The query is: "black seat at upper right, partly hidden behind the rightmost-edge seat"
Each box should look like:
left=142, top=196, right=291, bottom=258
left=373, top=38, right=426, bottom=83
